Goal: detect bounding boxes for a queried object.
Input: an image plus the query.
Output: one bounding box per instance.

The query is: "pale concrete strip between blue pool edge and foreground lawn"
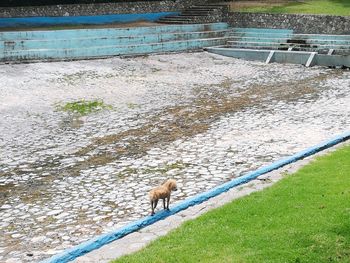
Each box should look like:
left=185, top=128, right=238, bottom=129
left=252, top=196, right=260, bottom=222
left=73, top=142, right=350, bottom=263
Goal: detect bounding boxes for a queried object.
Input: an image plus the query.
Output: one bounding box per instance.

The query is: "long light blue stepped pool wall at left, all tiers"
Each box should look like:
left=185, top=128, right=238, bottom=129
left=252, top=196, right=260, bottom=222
left=0, top=23, right=229, bottom=62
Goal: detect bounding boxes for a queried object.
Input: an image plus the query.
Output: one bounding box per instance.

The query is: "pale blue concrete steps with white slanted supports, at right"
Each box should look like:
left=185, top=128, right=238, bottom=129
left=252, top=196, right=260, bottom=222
left=207, top=28, right=350, bottom=67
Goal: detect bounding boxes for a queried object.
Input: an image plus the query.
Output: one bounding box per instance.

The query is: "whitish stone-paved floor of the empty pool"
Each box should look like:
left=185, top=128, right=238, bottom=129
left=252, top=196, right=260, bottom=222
left=0, top=53, right=350, bottom=262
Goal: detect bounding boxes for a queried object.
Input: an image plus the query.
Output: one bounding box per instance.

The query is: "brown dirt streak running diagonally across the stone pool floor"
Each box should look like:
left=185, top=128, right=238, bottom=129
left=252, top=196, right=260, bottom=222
left=71, top=71, right=341, bottom=170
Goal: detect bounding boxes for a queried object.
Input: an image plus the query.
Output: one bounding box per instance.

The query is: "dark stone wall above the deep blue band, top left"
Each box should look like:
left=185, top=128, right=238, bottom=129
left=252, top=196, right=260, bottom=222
left=0, top=0, right=203, bottom=18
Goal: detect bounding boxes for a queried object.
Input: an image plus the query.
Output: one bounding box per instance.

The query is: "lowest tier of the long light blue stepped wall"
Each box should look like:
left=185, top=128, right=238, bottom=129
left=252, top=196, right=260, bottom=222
left=0, top=37, right=231, bottom=62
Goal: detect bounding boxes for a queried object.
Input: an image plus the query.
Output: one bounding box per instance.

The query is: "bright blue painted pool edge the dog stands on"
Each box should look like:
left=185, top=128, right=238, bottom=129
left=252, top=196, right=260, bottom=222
left=42, top=131, right=350, bottom=263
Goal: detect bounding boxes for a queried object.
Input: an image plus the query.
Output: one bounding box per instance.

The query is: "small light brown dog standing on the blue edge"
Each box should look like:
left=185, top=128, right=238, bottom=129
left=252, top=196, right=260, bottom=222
left=149, top=179, right=177, bottom=215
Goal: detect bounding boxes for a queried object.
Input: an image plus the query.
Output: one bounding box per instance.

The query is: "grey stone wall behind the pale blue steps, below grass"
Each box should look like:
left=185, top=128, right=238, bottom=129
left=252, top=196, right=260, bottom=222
left=227, top=12, right=350, bottom=34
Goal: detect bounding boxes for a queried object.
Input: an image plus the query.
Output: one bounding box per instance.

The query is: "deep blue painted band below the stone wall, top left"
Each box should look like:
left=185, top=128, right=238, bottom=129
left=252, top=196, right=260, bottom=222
left=0, top=12, right=179, bottom=28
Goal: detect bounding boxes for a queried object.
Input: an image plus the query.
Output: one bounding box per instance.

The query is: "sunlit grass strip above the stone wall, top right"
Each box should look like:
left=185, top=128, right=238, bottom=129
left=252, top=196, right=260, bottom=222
left=237, top=0, right=350, bottom=16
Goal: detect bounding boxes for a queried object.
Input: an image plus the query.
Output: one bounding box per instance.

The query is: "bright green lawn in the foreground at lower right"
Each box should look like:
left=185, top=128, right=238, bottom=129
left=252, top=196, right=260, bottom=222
left=113, top=146, right=350, bottom=263
